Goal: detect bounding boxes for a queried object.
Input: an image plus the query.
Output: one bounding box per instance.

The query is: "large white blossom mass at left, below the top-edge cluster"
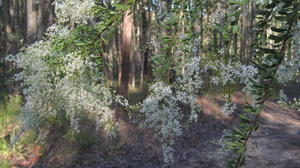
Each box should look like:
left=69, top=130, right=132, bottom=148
left=9, top=41, right=113, bottom=132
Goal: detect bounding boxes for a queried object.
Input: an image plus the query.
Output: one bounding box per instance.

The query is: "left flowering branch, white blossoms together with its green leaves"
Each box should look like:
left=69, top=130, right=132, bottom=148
left=7, top=0, right=134, bottom=139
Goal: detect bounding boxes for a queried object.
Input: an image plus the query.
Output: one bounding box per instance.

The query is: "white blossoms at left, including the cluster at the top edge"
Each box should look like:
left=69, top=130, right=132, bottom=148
left=7, top=0, right=115, bottom=133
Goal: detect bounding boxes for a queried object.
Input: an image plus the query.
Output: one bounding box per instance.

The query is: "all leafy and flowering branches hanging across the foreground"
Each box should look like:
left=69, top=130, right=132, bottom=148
left=7, top=0, right=300, bottom=167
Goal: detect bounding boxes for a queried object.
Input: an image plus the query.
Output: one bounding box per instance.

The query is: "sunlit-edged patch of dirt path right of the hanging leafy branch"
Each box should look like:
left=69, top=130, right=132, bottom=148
left=245, top=102, right=300, bottom=168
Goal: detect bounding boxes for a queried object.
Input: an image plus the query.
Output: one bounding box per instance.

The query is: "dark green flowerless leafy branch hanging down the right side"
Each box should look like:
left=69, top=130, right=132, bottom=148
left=227, top=0, right=299, bottom=168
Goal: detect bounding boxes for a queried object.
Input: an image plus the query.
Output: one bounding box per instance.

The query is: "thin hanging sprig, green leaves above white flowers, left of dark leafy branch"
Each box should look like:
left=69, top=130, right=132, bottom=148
left=207, top=0, right=257, bottom=116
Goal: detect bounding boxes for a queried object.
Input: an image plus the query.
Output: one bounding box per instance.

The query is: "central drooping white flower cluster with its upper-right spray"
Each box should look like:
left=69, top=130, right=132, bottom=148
left=141, top=57, right=203, bottom=164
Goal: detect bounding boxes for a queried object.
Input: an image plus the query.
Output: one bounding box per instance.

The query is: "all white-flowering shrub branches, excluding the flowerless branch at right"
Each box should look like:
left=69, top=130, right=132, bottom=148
left=2, top=0, right=272, bottom=164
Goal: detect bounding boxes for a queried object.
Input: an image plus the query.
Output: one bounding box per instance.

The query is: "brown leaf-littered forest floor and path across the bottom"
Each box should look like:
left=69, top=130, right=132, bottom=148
left=4, top=85, right=300, bottom=168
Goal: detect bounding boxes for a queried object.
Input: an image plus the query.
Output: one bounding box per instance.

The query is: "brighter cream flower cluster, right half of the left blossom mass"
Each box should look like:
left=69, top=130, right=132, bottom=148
left=57, top=52, right=113, bottom=133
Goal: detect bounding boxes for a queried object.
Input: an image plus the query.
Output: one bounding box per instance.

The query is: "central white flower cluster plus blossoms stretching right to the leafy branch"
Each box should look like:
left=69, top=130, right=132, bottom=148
left=141, top=57, right=257, bottom=164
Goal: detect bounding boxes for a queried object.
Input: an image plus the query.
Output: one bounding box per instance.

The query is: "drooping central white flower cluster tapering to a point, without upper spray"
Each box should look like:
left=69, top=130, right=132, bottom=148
left=141, top=82, right=195, bottom=163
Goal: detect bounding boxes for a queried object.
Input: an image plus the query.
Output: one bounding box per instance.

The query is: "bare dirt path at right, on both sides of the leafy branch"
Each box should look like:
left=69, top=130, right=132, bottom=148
left=172, top=93, right=300, bottom=168
